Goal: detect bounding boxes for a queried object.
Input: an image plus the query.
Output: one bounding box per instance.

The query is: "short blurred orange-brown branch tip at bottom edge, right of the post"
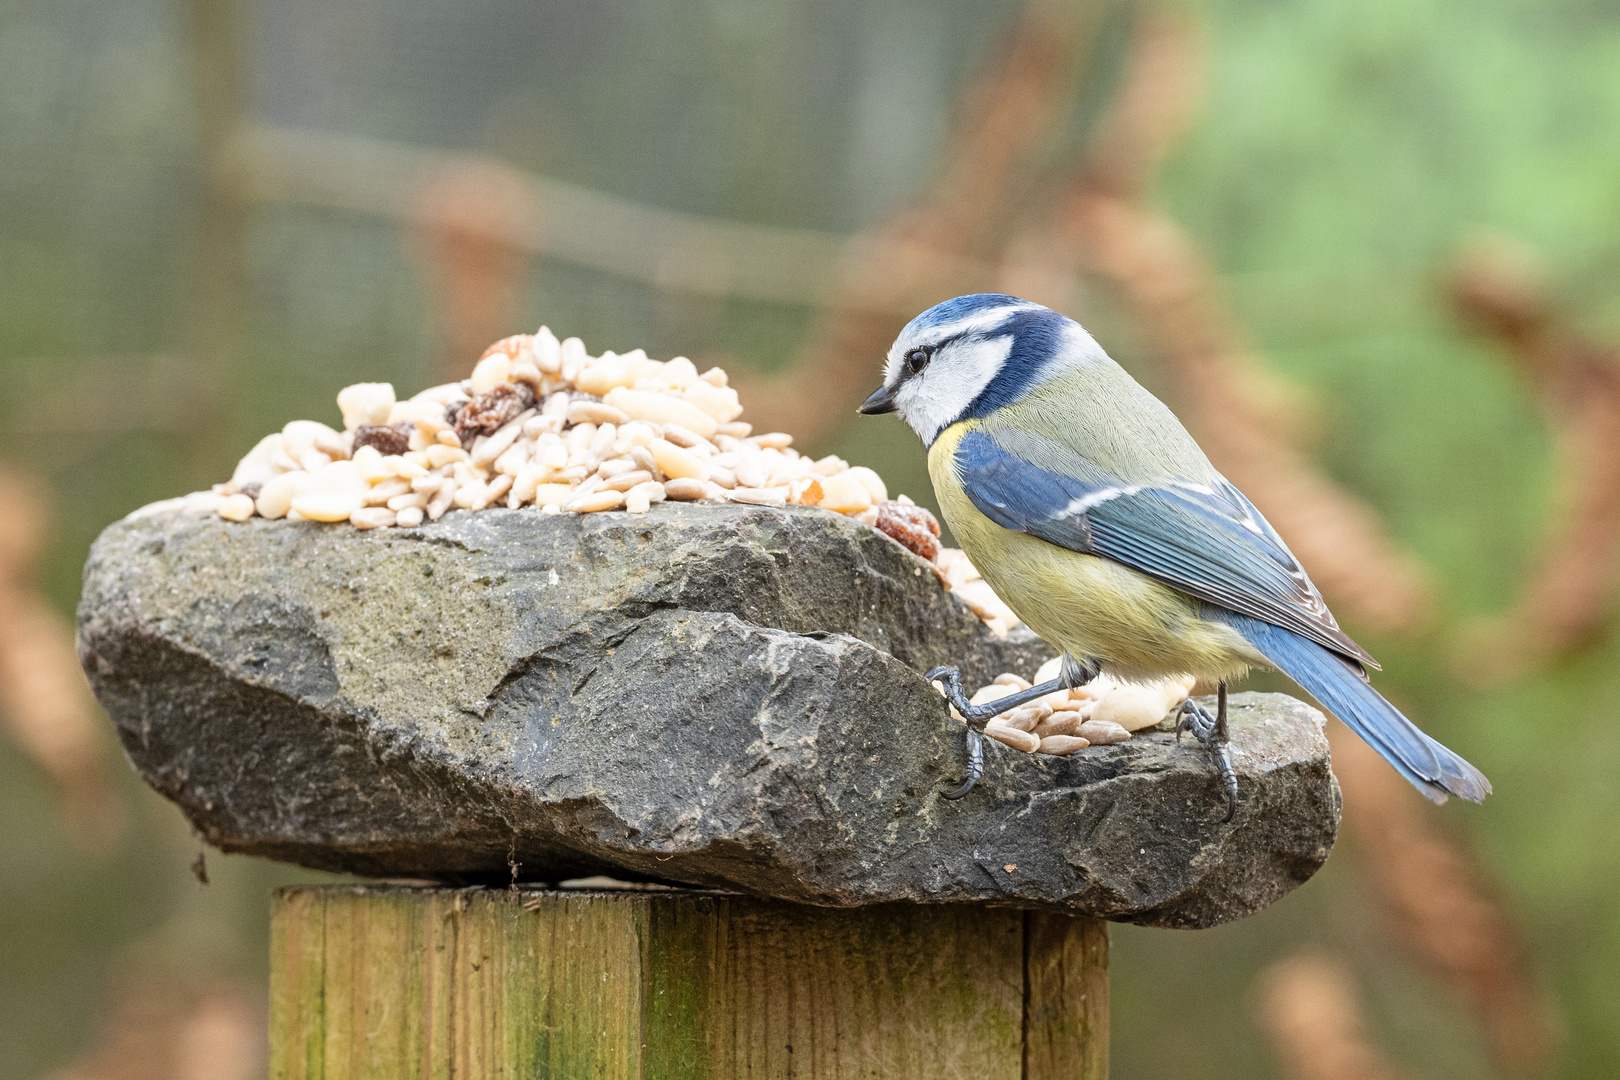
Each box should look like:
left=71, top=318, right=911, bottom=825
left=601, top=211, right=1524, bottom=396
left=1256, top=952, right=1405, bottom=1080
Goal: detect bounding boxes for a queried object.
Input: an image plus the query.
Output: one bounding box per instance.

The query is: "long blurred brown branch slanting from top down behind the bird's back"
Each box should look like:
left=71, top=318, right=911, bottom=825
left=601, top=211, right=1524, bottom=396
left=1050, top=13, right=1432, bottom=631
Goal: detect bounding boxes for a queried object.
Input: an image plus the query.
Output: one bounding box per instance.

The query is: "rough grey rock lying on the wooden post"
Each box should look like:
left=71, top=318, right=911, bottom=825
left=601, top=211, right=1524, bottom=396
left=79, top=504, right=1340, bottom=926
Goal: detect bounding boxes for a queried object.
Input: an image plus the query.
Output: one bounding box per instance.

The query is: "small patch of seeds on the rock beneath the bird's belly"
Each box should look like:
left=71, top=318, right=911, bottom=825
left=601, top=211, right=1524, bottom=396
left=935, top=656, right=1196, bottom=758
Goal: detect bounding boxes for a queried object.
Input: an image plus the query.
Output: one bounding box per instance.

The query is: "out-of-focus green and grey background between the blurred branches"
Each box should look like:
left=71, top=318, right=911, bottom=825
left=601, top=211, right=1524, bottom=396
left=0, top=0, right=1620, bottom=1080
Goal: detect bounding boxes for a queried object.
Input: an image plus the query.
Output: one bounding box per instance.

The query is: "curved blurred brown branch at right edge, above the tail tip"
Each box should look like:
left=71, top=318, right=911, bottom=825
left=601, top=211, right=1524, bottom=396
left=1448, top=243, right=1620, bottom=683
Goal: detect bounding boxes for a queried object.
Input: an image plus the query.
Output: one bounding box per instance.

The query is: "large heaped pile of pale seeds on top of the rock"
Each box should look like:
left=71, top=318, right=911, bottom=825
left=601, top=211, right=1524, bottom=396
left=131, top=327, right=1019, bottom=633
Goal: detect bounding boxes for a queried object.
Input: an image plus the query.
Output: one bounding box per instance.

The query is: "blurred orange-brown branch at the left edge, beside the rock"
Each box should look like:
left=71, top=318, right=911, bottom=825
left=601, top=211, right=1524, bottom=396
left=0, top=466, right=125, bottom=852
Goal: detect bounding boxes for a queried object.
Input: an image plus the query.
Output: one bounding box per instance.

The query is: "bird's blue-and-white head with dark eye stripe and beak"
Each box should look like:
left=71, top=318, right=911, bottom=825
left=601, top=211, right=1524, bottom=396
left=860, top=293, right=1102, bottom=445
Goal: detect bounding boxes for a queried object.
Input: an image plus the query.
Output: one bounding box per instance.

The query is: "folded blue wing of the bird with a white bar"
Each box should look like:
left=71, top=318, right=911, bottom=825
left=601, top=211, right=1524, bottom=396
left=956, top=431, right=1377, bottom=667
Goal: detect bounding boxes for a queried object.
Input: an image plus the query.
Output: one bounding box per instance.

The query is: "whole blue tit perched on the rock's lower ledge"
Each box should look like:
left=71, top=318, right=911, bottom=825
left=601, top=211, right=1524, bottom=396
left=860, top=293, right=1490, bottom=819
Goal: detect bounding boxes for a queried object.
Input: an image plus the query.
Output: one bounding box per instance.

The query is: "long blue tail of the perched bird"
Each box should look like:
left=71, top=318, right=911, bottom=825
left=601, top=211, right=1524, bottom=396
left=1221, top=612, right=1490, bottom=803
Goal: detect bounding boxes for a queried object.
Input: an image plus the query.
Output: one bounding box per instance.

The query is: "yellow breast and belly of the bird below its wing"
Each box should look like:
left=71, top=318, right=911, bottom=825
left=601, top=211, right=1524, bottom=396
left=928, top=421, right=1267, bottom=682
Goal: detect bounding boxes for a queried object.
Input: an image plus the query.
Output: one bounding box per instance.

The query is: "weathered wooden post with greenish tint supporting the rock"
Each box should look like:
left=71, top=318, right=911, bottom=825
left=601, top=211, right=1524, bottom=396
left=271, top=887, right=1108, bottom=1080
